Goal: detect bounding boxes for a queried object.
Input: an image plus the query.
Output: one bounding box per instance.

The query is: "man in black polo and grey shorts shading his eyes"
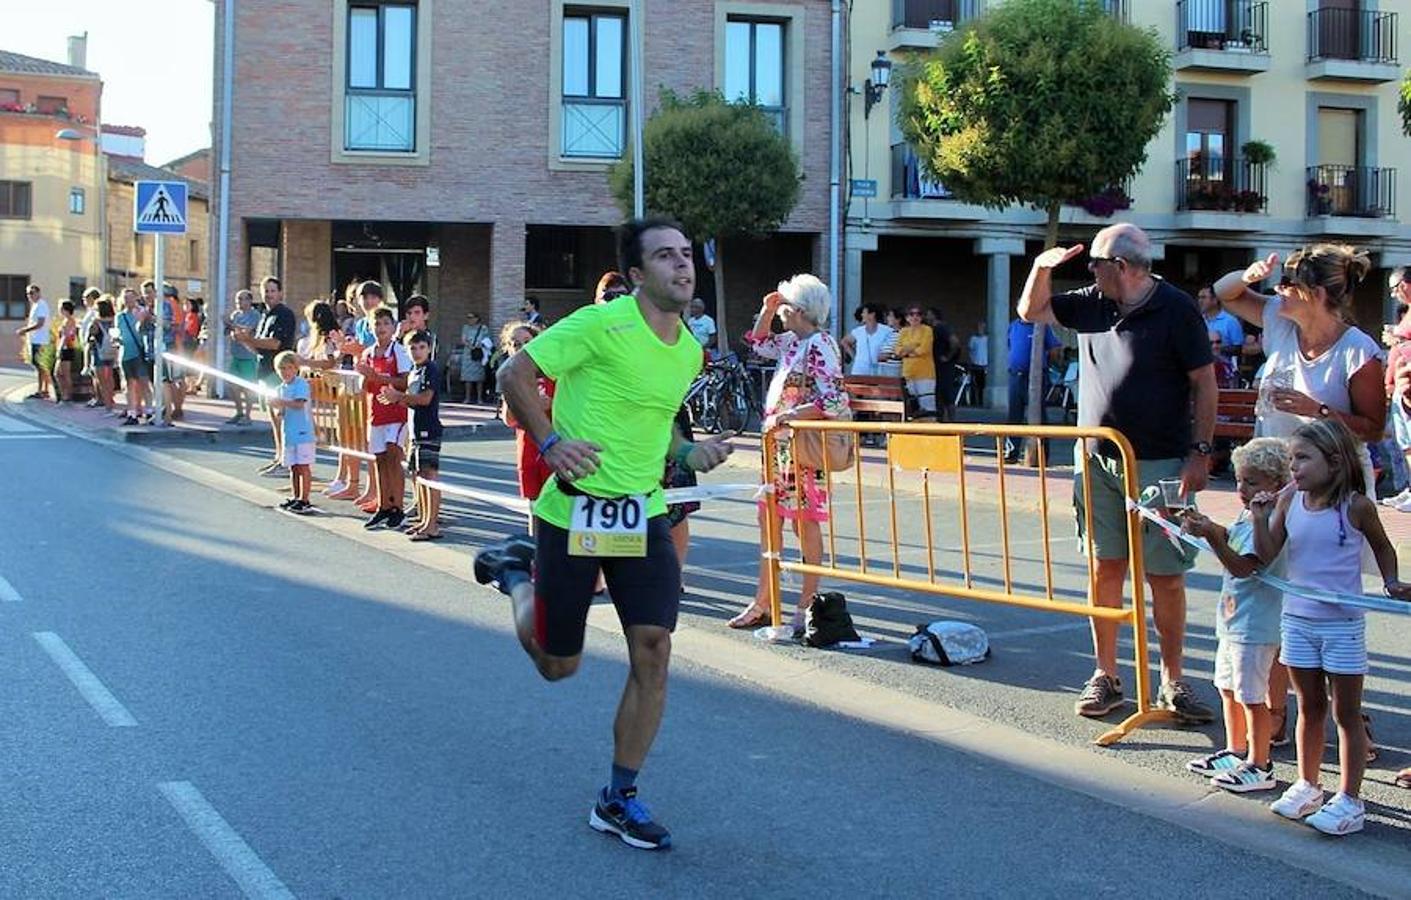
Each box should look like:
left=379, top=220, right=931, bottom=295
left=1019, top=224, right=1218, bottom=722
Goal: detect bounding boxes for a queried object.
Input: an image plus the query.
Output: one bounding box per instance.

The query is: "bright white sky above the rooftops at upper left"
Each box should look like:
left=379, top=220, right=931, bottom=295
left=9, top=0, right=214, bottom=165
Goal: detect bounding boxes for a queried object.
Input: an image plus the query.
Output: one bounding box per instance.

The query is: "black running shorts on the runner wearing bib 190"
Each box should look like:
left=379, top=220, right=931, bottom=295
left=535, top=516, right=682, bottom=656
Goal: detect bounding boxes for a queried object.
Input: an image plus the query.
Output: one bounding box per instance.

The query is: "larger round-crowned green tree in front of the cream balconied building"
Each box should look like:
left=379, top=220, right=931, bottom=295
left=896, top=0, right=1175, bottom=463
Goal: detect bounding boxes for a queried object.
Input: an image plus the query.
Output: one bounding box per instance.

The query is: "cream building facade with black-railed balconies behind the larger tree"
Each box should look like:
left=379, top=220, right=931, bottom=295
left=844, top=0, right=1411, bottom=402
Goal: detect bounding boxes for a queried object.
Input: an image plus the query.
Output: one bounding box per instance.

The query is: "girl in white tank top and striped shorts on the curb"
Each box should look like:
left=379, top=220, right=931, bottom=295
left=1250, top=419, right=1411, bottom=835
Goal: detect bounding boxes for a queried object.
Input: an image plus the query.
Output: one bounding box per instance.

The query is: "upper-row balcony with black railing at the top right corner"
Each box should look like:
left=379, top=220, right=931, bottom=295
left=1308, top=7, right=1401, bottom=82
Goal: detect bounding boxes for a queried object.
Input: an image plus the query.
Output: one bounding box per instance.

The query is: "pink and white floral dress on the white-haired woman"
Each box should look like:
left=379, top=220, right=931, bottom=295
left=746, top=332, right=849, bottom=522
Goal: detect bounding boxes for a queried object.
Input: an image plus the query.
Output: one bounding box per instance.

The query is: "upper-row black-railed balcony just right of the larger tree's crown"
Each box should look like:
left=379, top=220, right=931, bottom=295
left=1173, top=0, right=1270, bottom=73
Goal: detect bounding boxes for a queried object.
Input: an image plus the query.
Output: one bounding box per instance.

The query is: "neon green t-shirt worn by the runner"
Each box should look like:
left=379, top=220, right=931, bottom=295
left=525, top=295, right=701, bottom=528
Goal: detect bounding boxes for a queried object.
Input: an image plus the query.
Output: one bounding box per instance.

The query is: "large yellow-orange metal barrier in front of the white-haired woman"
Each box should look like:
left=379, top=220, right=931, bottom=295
left=762, top=420, right=1174, bottom=746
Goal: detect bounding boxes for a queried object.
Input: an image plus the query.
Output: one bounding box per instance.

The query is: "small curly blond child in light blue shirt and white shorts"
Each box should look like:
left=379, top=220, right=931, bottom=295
left=1182, top=437, right=1288, bottom=793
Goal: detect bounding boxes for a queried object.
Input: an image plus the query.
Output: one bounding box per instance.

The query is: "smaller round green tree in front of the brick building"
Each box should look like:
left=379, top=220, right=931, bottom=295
left=608, top=89, right=800, bottom=350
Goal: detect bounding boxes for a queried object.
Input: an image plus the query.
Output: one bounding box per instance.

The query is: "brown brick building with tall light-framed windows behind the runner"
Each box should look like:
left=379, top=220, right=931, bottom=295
left=213, top=0, right=831, bottom=358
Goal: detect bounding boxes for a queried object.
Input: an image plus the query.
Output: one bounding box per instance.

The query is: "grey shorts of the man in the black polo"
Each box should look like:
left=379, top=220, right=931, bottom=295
left=1072, top=443, right=1195, bottom=576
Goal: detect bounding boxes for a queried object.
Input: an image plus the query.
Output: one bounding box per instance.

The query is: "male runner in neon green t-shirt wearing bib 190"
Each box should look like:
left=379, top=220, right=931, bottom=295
left=474, top=219, right=731, bottom=849
